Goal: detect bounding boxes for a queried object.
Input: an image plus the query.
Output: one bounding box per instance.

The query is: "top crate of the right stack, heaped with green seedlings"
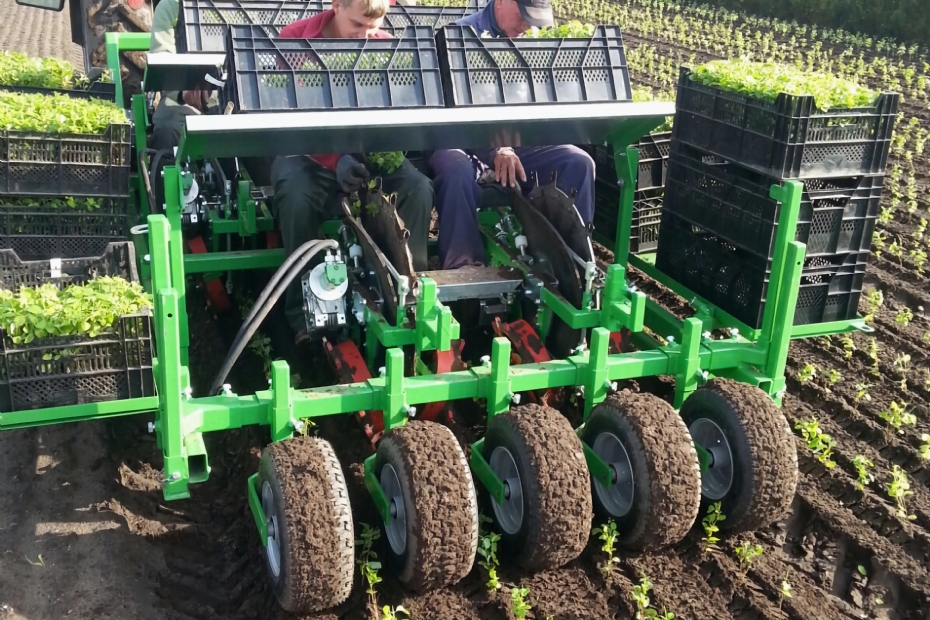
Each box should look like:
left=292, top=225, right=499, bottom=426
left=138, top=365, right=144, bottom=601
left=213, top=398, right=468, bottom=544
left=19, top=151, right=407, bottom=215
left=673, top=60, right=900, bottom=179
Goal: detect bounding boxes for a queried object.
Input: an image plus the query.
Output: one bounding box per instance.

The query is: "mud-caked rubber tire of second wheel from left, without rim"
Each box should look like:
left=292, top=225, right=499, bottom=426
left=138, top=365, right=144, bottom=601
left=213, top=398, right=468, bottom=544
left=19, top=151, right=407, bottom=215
left=375, top=421, right=478, bottom=592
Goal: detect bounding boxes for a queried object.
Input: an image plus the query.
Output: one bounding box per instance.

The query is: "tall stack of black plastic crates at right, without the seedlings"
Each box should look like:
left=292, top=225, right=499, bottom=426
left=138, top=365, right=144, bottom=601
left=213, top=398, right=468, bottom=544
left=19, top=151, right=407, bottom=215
left=656, top=68, right=899, bottom=329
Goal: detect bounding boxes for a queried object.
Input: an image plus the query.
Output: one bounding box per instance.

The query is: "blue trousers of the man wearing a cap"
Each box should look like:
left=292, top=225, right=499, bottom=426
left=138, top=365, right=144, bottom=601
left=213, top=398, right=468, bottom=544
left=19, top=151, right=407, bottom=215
left=429, top=146, right=594, bottom=269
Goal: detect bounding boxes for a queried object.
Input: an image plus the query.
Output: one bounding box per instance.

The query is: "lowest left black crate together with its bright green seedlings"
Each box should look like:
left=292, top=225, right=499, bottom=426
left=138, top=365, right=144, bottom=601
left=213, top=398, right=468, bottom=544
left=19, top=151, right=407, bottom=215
left=0, top=242, right=155, bottom=411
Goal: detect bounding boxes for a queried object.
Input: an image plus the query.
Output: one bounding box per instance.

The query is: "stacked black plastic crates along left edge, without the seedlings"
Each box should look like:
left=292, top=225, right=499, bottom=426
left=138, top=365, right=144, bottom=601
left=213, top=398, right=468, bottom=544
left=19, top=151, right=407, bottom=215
left=0, top=77, right=154, bottom=411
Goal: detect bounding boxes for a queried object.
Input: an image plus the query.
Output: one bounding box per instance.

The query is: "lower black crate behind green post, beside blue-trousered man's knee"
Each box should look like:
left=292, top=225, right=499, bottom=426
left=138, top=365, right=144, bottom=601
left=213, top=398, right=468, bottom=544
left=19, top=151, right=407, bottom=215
left=594, top=181, right=662, bottom=254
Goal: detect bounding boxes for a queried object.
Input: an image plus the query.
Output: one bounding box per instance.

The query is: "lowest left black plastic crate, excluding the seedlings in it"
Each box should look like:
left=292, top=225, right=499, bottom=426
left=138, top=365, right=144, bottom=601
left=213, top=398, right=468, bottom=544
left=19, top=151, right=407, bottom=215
left=0, top=242, right=155, bottom=411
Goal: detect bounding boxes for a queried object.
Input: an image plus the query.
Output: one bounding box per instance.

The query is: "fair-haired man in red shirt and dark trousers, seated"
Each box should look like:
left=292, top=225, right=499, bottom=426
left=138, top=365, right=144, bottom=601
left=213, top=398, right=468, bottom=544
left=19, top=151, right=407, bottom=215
left=271, top=0, right=434, bottom=344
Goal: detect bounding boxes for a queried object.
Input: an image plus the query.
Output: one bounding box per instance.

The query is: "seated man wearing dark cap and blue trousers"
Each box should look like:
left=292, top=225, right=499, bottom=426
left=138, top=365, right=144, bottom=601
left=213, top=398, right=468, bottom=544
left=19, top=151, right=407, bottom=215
left=429, top=0, right=594, bottom=269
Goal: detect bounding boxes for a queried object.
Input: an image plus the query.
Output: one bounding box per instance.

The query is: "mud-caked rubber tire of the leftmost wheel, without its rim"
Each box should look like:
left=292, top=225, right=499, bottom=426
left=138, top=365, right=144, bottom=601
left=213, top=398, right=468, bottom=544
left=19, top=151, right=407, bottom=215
left=258, top=437, right=355, bottom=614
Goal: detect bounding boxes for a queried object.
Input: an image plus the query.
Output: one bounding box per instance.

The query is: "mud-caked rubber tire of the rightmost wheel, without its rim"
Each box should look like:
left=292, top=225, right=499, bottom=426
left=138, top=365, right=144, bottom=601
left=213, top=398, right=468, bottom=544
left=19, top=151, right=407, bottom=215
left=681, top=379, right=798, bottom=533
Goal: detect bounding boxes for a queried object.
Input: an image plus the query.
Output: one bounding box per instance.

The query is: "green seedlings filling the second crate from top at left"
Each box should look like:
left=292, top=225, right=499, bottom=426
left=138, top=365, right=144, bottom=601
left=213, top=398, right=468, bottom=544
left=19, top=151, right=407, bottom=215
left=0, top=91, right=127, bottom=134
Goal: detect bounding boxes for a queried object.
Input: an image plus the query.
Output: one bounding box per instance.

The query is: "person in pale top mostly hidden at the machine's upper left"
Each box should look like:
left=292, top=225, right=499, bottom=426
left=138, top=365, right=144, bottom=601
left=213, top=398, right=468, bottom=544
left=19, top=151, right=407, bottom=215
left=149, top=0, right=219, bottom=152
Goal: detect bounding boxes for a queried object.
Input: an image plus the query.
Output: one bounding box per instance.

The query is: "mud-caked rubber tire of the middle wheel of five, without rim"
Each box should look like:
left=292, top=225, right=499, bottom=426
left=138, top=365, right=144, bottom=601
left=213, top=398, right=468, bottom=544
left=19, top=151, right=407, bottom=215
left=483, top=405, right=593, bottom=570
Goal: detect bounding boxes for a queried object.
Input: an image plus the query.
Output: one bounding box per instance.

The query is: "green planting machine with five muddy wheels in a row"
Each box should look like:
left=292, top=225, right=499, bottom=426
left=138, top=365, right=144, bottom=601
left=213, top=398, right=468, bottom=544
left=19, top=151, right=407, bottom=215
left=0, top=2, right=884, bottom=612
